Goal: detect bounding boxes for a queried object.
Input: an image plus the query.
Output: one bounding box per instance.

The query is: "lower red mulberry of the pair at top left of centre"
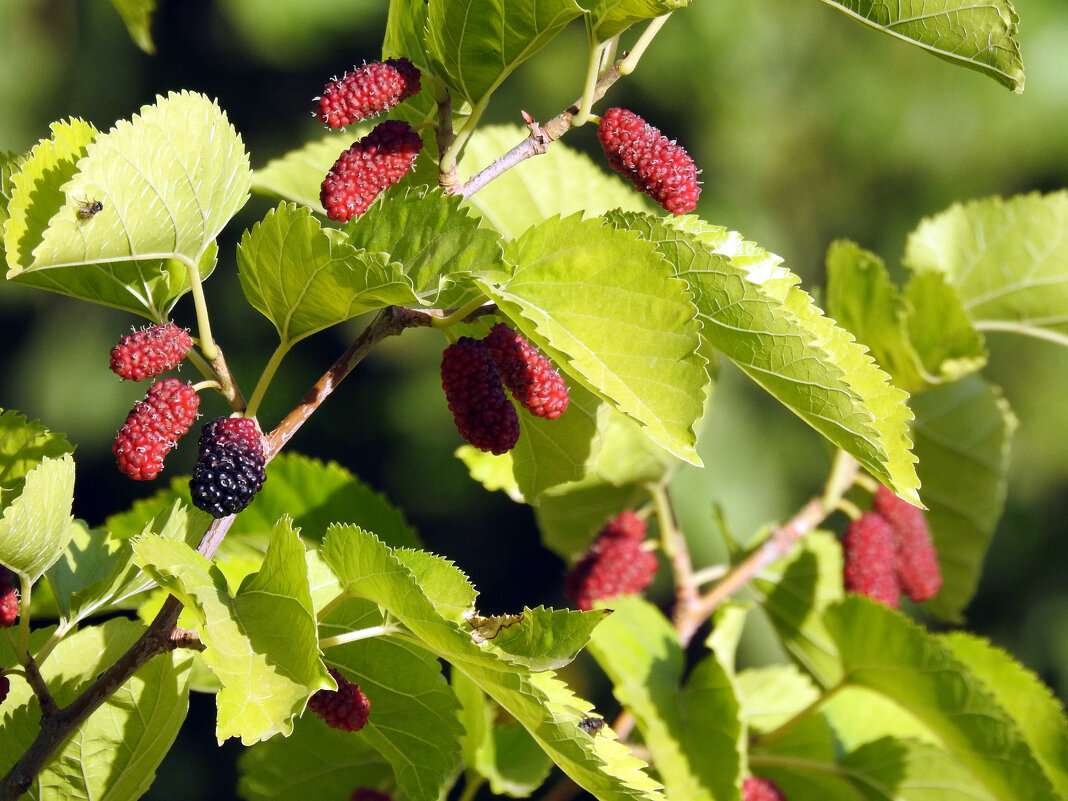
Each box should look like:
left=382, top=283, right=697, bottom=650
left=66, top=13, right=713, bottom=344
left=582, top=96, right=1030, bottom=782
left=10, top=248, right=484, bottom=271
left=319, top=120, right=423, bottom=222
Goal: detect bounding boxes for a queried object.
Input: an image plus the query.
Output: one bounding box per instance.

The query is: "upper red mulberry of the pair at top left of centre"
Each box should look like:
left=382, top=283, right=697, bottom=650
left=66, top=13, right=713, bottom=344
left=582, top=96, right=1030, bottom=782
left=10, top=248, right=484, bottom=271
left=318, top=59, right=420, bottom=128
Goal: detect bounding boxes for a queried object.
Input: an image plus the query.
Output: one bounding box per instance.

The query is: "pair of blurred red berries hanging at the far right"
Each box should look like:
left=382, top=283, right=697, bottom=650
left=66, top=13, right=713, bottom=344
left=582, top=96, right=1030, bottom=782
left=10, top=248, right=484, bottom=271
left=842, top=486, right=942, bottom=609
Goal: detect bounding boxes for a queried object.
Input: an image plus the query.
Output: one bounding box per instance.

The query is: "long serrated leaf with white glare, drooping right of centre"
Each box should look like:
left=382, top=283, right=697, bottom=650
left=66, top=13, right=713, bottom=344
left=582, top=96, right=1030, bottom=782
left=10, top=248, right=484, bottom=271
left=609, top=214, right=920, bottom=503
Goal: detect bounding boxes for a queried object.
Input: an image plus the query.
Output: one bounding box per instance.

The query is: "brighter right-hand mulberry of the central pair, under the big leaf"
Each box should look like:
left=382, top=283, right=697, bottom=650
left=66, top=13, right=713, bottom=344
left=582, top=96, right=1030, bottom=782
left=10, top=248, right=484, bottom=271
left=483, top=323, right=568, bottom=420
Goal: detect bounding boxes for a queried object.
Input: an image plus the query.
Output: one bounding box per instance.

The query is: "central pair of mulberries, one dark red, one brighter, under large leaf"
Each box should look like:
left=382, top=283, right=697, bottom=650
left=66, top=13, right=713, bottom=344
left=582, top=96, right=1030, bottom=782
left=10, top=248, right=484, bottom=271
left=441, top=323, right=569, bottom=454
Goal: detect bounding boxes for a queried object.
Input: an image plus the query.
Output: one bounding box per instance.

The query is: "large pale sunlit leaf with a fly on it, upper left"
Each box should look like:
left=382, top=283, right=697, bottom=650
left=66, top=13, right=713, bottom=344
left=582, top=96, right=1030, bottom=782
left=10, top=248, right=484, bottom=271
left=5, top=92, right=251, bottom=320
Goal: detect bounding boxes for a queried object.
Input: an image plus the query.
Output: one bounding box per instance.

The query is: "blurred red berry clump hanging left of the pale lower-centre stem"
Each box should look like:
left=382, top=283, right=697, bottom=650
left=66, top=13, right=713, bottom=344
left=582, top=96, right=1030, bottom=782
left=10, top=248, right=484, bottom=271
left=564, top=512, right=658, bottom=611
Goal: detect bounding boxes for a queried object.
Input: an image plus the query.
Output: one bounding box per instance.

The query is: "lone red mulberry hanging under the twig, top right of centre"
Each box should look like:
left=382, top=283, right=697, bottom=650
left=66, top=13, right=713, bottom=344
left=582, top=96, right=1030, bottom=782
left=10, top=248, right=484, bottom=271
left=597, top=108, right=701, bottom=215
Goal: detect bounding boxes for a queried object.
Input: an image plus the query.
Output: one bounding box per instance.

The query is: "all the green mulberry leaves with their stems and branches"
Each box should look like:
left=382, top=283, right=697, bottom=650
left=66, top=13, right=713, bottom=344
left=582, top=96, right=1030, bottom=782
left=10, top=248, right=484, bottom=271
left=0, top=0, right=1068, bottom=801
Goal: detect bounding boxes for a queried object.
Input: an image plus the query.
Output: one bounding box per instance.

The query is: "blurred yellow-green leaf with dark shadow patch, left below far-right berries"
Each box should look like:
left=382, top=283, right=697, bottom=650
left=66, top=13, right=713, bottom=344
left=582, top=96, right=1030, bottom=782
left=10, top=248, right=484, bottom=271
left=753, top=531, right=843, bottom=687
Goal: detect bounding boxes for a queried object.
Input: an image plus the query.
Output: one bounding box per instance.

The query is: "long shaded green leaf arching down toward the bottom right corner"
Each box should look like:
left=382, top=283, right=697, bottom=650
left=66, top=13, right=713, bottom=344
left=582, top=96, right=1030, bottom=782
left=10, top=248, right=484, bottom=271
left=824, top=595, right=1058, bottom=801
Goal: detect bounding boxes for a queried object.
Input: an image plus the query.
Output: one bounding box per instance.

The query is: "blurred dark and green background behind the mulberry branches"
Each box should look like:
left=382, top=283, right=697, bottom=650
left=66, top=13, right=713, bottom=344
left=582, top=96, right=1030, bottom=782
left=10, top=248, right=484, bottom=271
left=0, top=0, right=1068, bottom=799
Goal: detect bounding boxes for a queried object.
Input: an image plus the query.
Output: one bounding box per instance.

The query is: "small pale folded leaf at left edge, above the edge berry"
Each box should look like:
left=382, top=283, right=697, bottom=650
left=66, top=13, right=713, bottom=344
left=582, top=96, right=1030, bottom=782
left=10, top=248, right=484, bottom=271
left=0, top=454, right=75, bottom=584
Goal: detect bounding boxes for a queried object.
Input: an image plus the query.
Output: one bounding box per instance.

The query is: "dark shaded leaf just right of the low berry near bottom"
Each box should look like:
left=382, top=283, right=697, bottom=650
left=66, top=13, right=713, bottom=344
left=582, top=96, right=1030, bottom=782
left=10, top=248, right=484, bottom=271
left=320, top=600, right=464, bottom=801
